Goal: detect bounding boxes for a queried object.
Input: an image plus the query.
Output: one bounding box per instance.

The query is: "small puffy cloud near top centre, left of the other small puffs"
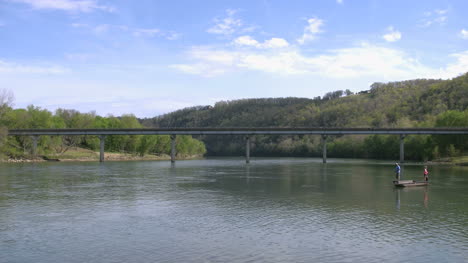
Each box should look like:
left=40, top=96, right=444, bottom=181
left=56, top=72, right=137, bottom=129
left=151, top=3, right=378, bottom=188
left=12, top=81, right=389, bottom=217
left=206, top=9, right=256, bottom=35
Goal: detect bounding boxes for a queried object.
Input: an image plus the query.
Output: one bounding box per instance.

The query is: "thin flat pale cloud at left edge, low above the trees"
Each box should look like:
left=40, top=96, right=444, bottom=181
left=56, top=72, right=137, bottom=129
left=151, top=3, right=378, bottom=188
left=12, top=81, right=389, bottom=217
left=0, top=60, right=69, bottom=74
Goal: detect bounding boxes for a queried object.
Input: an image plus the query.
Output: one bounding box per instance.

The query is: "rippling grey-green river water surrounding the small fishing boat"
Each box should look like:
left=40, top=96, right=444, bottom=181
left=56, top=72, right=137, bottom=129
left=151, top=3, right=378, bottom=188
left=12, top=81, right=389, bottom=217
left=0, top=158, right=468, bottom=262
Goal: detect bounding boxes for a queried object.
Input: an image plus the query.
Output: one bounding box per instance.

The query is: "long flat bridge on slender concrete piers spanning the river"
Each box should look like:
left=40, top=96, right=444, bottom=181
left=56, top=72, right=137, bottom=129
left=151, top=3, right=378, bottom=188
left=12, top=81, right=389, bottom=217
left=8, top=127, right=468, bottom=163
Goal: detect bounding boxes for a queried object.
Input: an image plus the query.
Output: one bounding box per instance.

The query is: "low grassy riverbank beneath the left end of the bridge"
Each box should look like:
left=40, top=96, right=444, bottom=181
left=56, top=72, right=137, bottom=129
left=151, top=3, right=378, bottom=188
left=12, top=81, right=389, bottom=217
left=1, top=147, right=203, bottom=163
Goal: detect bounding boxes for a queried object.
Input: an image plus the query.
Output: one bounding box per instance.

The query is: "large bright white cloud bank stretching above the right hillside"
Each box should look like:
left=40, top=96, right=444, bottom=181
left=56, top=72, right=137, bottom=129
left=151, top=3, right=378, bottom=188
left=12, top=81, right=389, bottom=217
left=170, top=42, right=468, bottom=81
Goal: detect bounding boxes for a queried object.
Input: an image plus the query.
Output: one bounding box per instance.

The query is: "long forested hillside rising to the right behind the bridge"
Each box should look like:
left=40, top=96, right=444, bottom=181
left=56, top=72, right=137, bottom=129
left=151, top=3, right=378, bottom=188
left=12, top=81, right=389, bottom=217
left=141, top=73, right=468, bottom=160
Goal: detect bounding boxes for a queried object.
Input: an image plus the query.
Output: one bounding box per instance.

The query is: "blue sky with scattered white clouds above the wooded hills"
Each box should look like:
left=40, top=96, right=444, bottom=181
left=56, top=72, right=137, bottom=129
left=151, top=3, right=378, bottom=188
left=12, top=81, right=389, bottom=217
left=0, top=0, right=468, bottom=117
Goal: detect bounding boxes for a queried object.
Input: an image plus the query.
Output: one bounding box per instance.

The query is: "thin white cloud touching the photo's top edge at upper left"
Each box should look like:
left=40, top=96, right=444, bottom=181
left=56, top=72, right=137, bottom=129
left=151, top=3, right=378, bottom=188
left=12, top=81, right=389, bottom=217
left=10, top=0, right=115, bottom=13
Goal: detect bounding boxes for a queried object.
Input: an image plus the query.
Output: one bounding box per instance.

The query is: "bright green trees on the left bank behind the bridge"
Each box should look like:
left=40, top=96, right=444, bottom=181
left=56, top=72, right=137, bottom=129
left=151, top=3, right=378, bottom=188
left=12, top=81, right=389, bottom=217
left=0, top=100, right=206, bottom=158
